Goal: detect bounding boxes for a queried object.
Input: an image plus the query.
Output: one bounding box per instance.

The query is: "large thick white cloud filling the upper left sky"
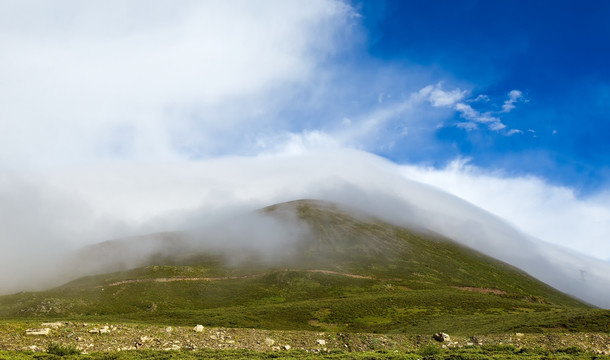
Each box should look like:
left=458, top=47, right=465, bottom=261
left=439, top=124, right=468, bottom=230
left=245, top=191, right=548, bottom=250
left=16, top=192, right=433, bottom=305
left=0, top=0, right=351, bottom=166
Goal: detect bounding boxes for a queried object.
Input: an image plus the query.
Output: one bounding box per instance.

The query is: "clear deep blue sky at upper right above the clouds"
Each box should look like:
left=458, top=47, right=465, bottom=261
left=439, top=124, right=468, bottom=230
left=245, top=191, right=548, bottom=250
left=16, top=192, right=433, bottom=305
left=358, top=1, right=610, bottom=194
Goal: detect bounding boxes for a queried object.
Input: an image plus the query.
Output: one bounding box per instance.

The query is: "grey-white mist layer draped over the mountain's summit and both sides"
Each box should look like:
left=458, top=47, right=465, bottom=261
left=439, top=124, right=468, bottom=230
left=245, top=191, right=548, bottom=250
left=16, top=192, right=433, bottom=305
left=0, top=151, right=610, bottom=307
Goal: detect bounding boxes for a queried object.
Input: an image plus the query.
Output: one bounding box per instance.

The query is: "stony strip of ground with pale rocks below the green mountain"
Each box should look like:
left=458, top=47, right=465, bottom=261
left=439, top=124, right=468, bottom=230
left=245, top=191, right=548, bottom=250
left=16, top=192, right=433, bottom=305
left=0, top=322, right=610, bottom=355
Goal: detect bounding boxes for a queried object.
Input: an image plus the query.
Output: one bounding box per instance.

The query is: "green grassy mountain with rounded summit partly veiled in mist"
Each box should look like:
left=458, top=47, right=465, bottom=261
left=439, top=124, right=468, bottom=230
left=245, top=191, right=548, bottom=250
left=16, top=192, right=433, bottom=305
left=0, top=200, right=610, bottom=334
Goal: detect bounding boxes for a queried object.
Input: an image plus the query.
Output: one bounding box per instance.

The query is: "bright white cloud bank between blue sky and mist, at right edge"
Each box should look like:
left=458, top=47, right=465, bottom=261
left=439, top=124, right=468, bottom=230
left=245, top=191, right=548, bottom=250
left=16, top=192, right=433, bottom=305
left=404, top=160, right=610, bottom=260
